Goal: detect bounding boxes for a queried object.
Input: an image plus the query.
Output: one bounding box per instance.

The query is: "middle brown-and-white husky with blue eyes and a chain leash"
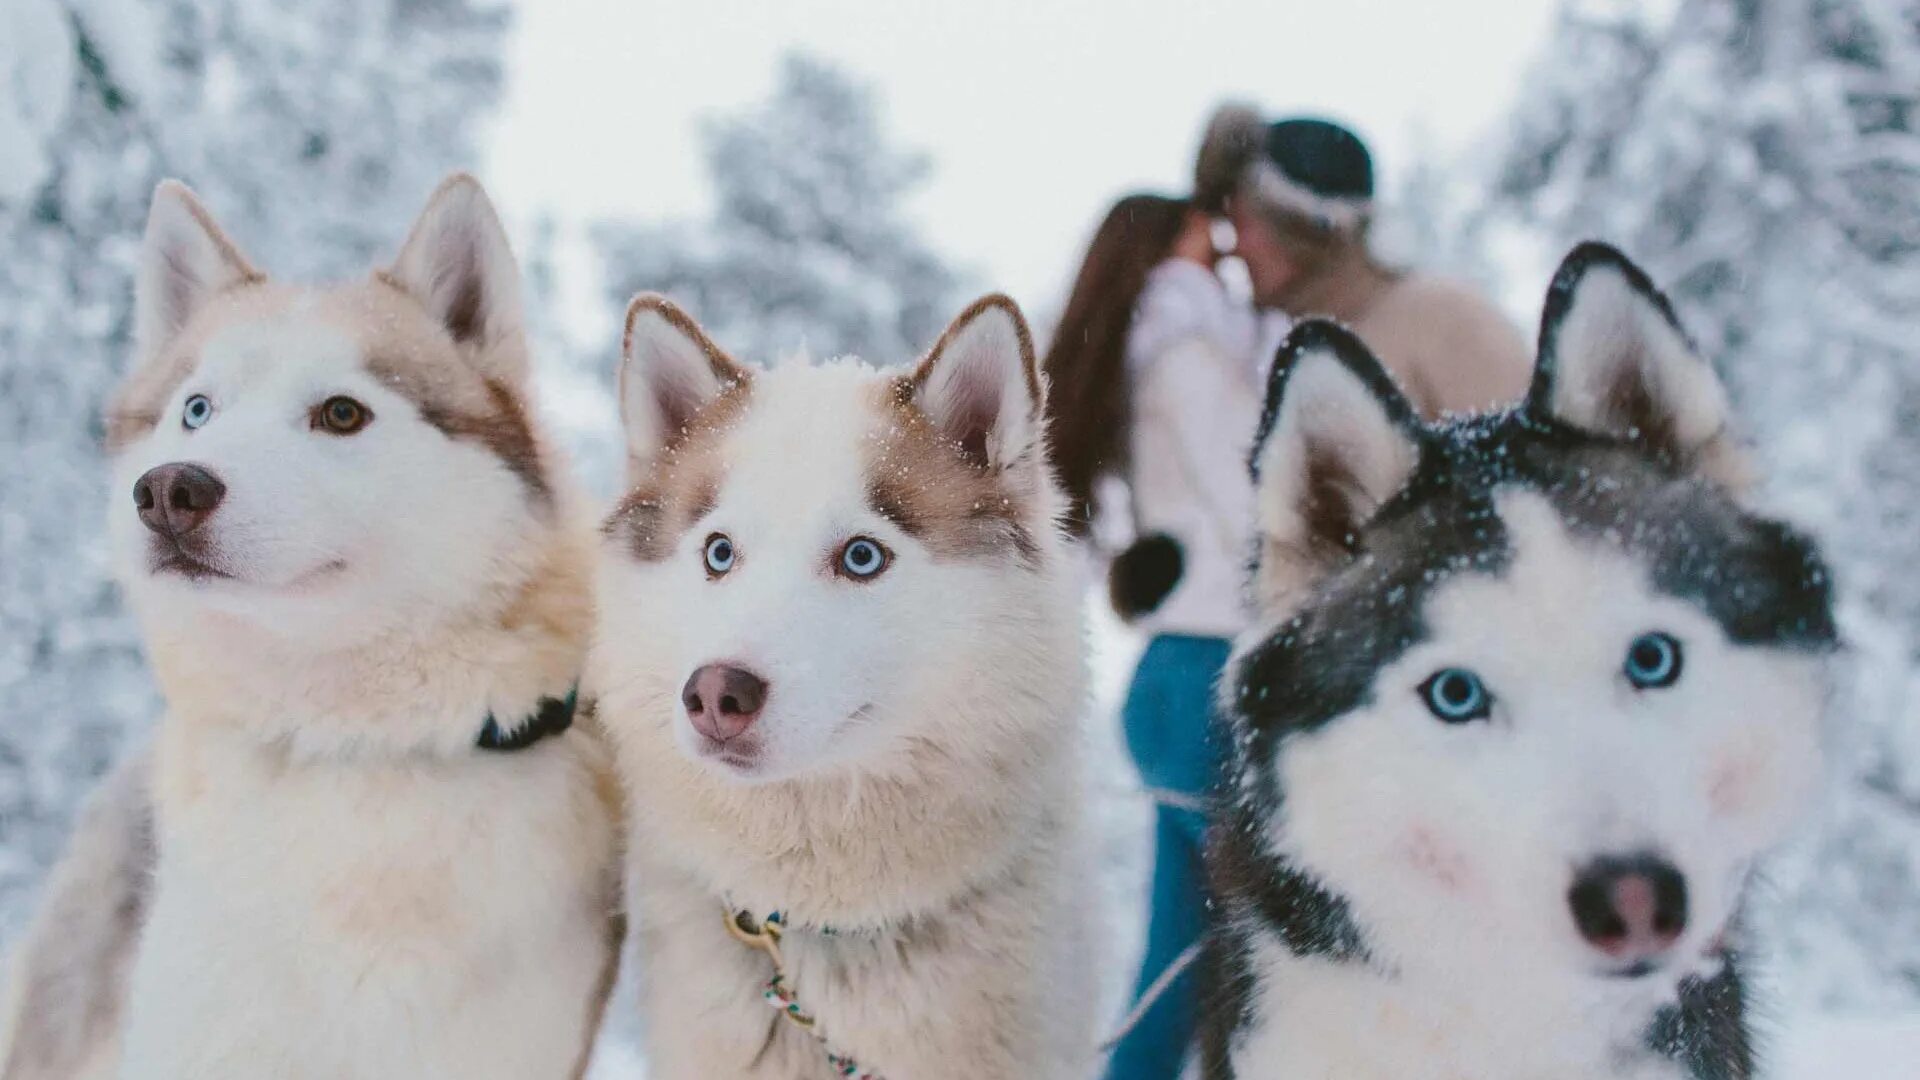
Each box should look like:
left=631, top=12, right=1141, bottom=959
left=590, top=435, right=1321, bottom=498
left=588, top=296, right=1092, bottom=1080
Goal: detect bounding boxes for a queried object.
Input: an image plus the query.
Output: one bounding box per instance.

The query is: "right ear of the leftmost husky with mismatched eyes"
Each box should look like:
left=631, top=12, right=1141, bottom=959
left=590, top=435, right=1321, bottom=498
left=384, top=173, right=530, bottom=384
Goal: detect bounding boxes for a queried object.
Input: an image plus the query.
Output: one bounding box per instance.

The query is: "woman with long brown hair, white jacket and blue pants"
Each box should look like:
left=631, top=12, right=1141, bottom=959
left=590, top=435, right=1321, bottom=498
left=1046, top=194, right=1279, bottom=1080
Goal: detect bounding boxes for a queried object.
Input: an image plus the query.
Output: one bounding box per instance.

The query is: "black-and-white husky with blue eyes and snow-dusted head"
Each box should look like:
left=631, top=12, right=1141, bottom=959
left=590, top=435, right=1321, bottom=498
left=1202, top=244, right=1836, bottom=1080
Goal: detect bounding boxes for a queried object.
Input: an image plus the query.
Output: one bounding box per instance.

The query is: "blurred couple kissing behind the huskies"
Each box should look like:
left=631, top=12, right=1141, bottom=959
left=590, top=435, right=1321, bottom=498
left=1046, top=106, right=1532, bottom=1080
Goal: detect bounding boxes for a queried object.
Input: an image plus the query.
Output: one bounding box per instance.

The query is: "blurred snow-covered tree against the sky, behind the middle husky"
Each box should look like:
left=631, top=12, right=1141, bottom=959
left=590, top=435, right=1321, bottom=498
left=593, top=56, right=956, bottom=363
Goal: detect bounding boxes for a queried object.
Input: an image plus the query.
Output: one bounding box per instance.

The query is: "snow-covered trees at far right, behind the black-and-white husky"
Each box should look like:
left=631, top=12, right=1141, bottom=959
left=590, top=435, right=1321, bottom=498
left=1492, top=0, right=1920, bottom=1005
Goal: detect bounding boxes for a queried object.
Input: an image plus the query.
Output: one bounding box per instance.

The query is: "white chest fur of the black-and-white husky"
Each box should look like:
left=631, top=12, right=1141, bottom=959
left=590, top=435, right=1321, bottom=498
left=1233, top=940, right=1686, bottom=1080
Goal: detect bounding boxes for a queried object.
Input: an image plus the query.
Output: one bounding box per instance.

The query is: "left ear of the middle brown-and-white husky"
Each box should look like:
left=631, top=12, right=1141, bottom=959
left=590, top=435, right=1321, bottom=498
left=620, top=292, right=751, bottom=480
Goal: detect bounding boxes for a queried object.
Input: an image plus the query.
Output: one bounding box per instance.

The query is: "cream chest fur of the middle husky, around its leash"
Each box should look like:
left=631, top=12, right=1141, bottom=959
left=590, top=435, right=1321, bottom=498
left=632, top=834, right=1094, bottom=1080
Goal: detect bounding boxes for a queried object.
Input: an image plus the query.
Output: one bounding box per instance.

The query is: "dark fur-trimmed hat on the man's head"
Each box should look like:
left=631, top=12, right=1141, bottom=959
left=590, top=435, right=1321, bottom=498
left=1194, top=104, right=1373, bottom=229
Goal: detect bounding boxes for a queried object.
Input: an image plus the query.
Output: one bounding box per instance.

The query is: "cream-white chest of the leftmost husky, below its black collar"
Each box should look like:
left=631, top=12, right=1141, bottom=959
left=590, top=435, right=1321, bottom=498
left=123, top=724, right=612, bottom=1080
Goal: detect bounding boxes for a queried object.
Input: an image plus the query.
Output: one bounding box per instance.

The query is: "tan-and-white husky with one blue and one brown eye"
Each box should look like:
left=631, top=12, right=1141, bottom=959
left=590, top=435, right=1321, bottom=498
left=0, top=177, right=616, bottom=1080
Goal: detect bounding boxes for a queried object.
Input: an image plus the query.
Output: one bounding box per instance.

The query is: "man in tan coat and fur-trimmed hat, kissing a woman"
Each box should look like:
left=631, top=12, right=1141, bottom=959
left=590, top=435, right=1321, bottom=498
left=1194, top=106, right=1532, bottom=417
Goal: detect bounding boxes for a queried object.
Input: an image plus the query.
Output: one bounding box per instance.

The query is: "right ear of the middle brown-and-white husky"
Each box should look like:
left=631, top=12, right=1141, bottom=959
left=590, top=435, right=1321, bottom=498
left=908, top=292, right=1046, bottom=469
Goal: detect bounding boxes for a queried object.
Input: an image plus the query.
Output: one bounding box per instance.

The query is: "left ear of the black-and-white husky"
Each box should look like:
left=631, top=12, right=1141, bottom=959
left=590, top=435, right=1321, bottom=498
left=1252, top=319, right=1423, bottom=615
